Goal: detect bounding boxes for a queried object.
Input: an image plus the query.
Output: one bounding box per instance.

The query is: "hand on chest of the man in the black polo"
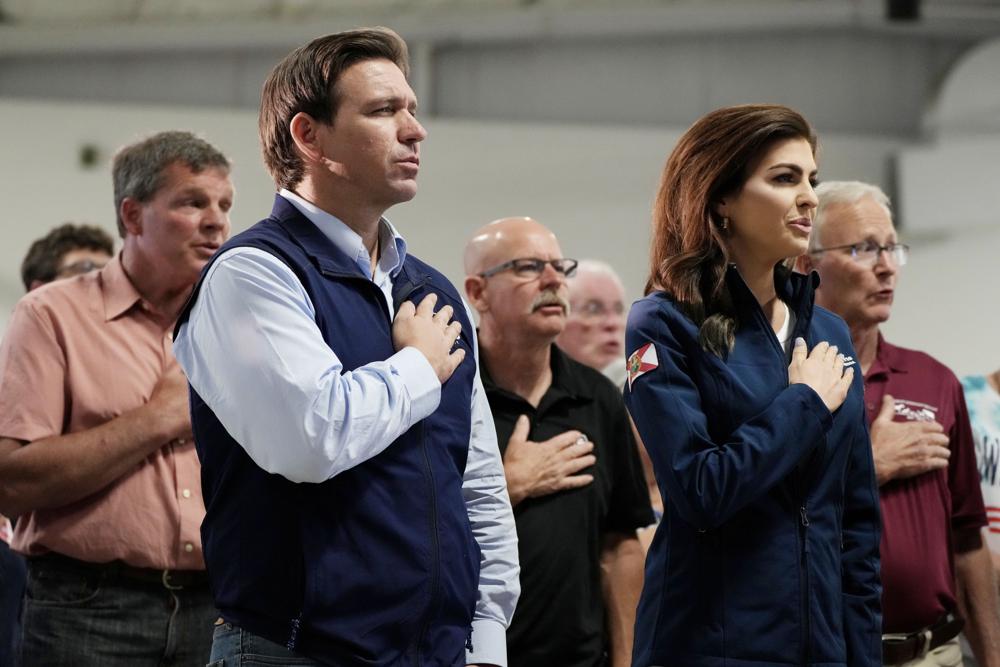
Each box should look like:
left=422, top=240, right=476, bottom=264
left=503, top=415, right=597, bottom=505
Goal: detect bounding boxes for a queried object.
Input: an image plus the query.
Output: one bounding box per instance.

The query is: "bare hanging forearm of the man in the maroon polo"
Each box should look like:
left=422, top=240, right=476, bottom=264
left=955, top=539, right=1000, bottom=667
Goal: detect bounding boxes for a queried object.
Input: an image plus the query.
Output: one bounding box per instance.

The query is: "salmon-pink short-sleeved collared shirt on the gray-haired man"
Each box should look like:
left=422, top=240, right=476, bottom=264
left=0, top=255, right=205, bottom=570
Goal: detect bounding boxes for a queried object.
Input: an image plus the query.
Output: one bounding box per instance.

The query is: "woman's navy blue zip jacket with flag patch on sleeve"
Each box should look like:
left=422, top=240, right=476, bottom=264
left=625, top=267, right=881, bottom=667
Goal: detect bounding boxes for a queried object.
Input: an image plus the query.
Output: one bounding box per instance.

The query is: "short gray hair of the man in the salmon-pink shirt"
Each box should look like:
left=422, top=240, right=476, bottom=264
left=111, top=130, right=230, bottom=238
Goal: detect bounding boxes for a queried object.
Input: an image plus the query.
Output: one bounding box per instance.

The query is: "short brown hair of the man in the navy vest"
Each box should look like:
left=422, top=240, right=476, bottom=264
left=258, top=28, right=410, bottom=189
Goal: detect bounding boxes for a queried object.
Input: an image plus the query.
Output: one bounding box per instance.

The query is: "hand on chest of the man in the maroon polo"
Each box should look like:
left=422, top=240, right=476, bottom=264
left=871, top=394, right=951, bottom=486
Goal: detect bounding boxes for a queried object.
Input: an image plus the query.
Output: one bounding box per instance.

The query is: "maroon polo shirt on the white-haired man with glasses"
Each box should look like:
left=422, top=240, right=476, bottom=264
left=865, top=335, right=987, bottom=633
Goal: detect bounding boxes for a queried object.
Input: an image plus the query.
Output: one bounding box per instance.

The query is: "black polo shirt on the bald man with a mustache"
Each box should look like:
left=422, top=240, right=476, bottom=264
left=480, top=345, right=653, bottom=667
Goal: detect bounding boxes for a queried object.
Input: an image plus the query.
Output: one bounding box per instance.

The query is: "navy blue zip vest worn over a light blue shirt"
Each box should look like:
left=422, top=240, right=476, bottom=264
left=178, top=197, right=480, bottom=667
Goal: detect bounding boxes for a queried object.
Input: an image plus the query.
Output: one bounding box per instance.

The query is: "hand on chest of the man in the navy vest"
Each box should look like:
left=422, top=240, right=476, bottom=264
left=392, top=293, right=465, bottom=383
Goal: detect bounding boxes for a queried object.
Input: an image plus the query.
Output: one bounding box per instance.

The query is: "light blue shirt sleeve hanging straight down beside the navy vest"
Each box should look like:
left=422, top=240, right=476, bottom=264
left=462, top=305, right=521, bottom=667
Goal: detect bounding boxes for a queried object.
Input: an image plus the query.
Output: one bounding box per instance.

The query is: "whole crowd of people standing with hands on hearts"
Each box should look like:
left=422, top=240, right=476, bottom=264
left=0, top=23, right=1000, bottom=667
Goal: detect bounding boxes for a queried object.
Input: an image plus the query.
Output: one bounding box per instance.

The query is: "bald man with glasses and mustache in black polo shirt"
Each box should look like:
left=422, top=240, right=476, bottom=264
left=465, top=218, right=652, bottom=667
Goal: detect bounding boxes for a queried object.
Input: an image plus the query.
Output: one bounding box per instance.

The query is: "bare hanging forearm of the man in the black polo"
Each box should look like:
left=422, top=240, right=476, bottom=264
left=601, top=534, right=643, bottom=667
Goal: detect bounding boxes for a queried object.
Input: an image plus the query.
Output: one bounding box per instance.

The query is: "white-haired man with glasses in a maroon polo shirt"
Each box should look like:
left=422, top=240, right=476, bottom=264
left=798, top=182, right=1000, bottom=667
